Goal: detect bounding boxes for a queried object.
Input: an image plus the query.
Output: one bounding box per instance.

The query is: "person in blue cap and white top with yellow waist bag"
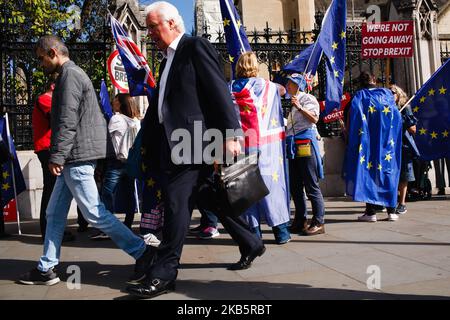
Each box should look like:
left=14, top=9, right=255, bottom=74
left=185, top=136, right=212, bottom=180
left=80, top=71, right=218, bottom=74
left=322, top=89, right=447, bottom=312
left=286, top=73, right=325, bottom=236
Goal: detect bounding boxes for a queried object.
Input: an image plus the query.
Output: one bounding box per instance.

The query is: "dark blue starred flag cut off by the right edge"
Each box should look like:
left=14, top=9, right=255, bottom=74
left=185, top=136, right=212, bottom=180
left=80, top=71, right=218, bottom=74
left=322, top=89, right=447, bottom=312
left=411, top=60, right=450, bottom=161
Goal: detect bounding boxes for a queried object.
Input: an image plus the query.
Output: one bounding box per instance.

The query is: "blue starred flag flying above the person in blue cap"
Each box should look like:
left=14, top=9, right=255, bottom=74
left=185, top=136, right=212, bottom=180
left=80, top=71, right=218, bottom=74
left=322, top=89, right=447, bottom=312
left=283, top=0, right=347, bottom=115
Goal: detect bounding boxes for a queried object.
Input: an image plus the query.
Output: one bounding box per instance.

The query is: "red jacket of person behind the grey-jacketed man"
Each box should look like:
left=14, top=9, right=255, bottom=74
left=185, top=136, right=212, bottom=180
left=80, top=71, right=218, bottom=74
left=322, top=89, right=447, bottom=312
left=32, top=91, right=52, bottom=152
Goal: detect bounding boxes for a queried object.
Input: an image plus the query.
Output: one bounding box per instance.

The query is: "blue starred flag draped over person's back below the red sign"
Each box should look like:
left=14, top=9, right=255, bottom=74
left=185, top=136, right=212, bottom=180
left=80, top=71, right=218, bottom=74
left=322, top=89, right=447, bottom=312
left=345, top=88, right=402, bottom=207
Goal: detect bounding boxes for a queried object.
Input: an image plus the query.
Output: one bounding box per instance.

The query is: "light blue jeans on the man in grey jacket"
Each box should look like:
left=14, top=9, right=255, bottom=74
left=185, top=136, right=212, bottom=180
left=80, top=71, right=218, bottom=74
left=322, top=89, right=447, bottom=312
left=38, top=161, right=146, bottom=272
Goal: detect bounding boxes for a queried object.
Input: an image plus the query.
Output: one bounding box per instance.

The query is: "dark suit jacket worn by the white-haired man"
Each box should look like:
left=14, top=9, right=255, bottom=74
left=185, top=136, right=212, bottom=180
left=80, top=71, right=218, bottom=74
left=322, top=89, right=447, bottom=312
left=143, top=35, right=241, bottom=168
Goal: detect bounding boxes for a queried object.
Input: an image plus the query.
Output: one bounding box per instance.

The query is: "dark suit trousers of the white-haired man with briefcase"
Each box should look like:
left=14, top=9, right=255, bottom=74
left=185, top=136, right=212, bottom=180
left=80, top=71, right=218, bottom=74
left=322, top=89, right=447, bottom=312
left=148, top=131, right=263, bottom=280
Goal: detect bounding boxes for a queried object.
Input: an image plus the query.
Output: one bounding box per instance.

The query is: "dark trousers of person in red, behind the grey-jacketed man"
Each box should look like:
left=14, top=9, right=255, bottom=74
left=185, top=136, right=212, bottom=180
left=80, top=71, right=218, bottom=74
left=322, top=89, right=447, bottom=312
left=36, top=150, right=88, bottom=238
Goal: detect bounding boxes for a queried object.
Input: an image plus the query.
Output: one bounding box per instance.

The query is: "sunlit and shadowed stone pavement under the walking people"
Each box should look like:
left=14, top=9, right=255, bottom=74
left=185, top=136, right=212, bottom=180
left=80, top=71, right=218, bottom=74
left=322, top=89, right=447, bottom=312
left=0, top=196, right=450, bottom=300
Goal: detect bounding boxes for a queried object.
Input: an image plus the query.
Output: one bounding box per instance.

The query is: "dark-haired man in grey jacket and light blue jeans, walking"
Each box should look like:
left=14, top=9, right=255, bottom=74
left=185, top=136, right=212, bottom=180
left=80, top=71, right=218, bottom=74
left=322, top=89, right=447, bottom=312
left=20, top=36, right=151, bottom=285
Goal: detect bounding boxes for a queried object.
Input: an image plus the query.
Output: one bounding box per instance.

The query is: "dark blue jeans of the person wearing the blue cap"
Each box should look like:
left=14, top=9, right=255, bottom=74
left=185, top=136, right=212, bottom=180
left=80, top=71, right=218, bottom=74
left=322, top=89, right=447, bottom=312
left=289, top=156, right=325, bottom=224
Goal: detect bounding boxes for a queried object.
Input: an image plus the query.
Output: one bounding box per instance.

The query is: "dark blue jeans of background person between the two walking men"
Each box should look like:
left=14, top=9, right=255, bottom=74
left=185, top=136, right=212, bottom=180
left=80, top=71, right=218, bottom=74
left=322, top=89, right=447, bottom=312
left=101, top=159, right=137, bottom=229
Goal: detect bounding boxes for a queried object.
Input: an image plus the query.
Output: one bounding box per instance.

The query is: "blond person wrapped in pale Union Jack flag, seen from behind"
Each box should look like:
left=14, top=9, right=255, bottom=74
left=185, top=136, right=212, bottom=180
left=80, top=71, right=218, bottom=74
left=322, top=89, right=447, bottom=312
left=231, top=52, right=291, bottom=244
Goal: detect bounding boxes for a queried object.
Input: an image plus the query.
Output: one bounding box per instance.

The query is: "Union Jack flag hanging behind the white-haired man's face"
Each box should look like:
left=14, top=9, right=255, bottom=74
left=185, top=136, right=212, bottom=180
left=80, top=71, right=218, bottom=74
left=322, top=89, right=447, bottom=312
left=111, top=15, right=156, bottom=97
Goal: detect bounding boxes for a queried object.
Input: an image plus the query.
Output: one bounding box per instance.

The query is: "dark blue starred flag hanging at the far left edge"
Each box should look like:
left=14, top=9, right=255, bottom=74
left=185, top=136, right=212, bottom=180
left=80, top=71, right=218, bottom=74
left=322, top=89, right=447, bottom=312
left=0, top=117, right=26, bottom=208
